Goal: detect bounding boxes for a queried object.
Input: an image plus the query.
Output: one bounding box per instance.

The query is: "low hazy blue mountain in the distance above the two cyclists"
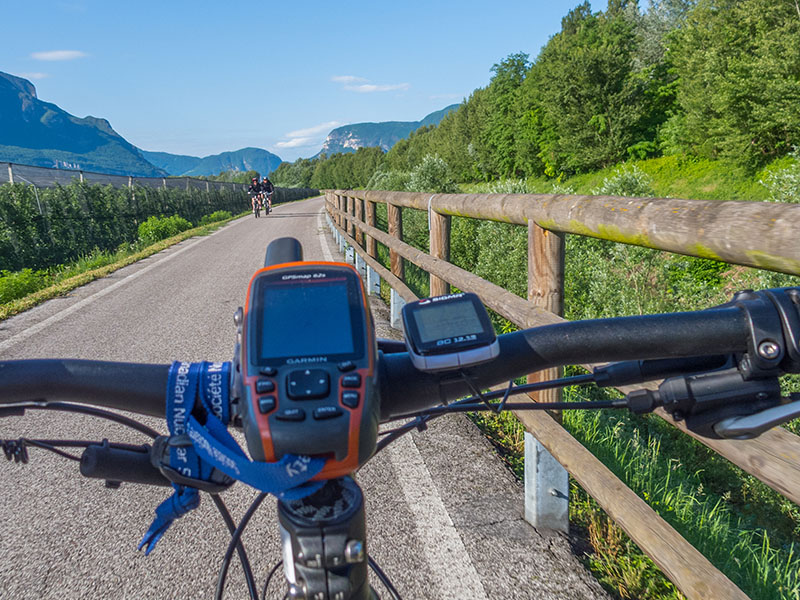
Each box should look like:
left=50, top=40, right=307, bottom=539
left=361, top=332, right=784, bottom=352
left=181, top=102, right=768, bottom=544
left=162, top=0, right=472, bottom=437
left=141, top=148, right=281, bottom=177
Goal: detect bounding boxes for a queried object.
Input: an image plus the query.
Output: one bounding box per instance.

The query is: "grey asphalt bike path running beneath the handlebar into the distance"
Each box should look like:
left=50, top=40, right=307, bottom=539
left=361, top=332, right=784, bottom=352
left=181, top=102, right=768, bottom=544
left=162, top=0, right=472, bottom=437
left=0, top=198, right=606, bottom=600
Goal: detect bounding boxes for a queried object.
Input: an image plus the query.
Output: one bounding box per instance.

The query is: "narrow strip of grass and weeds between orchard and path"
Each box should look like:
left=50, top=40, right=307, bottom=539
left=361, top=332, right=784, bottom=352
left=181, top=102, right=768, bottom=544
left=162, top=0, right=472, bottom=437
left=0, top=213, right=249, bottom=321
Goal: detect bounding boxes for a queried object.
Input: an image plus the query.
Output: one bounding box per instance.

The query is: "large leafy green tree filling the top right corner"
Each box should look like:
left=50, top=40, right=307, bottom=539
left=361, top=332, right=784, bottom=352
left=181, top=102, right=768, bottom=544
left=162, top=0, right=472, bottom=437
left=670, top=0, right=800, bottom=168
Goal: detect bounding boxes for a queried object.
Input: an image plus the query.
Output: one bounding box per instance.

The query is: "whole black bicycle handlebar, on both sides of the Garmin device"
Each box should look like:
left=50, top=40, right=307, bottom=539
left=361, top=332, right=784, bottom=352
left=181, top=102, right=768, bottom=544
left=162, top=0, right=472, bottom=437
left=0, top=306, right=782, bottom=421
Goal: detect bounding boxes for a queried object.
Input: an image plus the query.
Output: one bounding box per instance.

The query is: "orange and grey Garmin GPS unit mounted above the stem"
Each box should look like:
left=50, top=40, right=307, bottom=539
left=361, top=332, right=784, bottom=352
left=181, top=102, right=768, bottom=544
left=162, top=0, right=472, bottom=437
left=240, top=262, right=380, bottom=479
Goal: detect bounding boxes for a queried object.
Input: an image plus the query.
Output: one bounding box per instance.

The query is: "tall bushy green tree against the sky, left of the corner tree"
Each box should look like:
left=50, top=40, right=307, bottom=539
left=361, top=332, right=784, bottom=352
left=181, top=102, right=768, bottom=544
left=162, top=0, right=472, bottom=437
left=522, top=2, right=647, bottom=174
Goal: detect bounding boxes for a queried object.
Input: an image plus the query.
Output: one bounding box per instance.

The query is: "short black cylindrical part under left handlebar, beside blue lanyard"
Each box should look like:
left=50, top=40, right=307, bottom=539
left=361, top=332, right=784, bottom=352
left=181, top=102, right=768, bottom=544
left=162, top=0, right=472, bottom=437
left=81, top=441, right=170, bottom=486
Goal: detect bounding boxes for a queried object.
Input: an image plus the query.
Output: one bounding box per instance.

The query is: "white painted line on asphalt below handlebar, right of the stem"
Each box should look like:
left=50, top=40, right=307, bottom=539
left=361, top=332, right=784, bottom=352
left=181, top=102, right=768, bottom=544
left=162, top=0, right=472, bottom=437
left=386, top=435, right=488, bottom=600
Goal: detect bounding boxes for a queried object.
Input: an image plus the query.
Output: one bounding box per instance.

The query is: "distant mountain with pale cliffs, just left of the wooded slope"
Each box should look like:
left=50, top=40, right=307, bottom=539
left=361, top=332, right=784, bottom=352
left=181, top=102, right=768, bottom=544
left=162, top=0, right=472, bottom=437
left=319, top=104, right=460, bottom=154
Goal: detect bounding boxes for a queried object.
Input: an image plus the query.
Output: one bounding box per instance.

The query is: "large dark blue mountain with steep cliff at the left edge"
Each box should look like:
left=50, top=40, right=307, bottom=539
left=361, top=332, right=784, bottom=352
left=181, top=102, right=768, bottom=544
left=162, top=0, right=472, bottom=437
left=0, top=72, right=166, bottom=177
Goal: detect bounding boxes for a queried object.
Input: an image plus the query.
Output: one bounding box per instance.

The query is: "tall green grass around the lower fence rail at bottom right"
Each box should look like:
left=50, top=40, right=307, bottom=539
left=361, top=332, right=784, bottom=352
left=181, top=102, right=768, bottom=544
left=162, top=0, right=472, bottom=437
left=472, top=376, right=800, bottom=600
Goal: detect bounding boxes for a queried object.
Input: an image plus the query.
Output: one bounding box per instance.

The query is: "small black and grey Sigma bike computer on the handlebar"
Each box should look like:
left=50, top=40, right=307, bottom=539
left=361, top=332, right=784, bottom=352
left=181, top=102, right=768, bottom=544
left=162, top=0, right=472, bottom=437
left=403, top=293, right=500, bottom=372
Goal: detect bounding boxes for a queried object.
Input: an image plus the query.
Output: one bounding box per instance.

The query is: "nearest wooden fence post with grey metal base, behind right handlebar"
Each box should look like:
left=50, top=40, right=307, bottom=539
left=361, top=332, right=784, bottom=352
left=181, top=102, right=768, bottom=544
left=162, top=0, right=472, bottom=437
left=525, top=221, right=569, bottom=532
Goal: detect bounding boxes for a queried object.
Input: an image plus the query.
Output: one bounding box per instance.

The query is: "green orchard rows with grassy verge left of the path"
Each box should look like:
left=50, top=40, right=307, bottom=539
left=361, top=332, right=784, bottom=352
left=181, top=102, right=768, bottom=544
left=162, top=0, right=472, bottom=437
left=0, top=181, right=249, bottom=318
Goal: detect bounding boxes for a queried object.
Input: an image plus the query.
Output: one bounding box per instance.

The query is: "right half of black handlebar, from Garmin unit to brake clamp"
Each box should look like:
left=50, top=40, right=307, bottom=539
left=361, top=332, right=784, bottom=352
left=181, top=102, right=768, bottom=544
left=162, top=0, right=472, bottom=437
left=380, top=308, right=747, bottom=420
